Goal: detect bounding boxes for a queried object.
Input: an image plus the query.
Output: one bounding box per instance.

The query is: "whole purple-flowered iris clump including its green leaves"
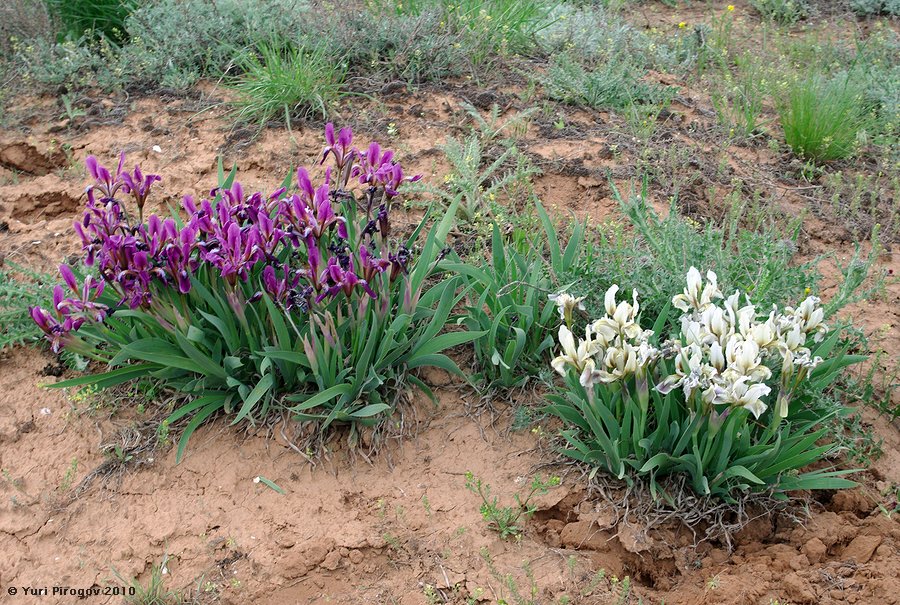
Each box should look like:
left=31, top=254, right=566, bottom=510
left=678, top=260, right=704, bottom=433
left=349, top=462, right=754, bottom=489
left=31, top=124, right=482, bottom=459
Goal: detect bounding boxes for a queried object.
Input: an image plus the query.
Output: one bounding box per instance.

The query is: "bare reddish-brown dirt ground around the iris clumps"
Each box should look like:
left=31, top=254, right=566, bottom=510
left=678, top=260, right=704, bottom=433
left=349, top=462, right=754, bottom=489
left=0, top=69, right=900, bottom=605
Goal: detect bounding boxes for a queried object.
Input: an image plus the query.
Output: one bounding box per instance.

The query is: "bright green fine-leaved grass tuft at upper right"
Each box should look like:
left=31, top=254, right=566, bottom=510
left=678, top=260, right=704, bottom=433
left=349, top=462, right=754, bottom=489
left=779, top=75, right=872, bottom=162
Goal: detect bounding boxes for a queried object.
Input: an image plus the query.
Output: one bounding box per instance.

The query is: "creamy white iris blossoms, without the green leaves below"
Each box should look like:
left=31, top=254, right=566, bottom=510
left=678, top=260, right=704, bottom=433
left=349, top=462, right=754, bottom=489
left=552, top=267, right=828, bottom=419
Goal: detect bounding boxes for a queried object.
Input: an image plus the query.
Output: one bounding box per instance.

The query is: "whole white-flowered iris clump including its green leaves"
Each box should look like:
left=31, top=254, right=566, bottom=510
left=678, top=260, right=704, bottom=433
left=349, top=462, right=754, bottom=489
left=547, top=267, right=864, bottom=500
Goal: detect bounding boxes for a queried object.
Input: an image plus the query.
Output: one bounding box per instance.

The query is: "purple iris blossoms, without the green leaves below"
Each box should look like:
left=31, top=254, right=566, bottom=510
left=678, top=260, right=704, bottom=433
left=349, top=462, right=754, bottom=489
left=31, top=123, right=419, bottom=351
